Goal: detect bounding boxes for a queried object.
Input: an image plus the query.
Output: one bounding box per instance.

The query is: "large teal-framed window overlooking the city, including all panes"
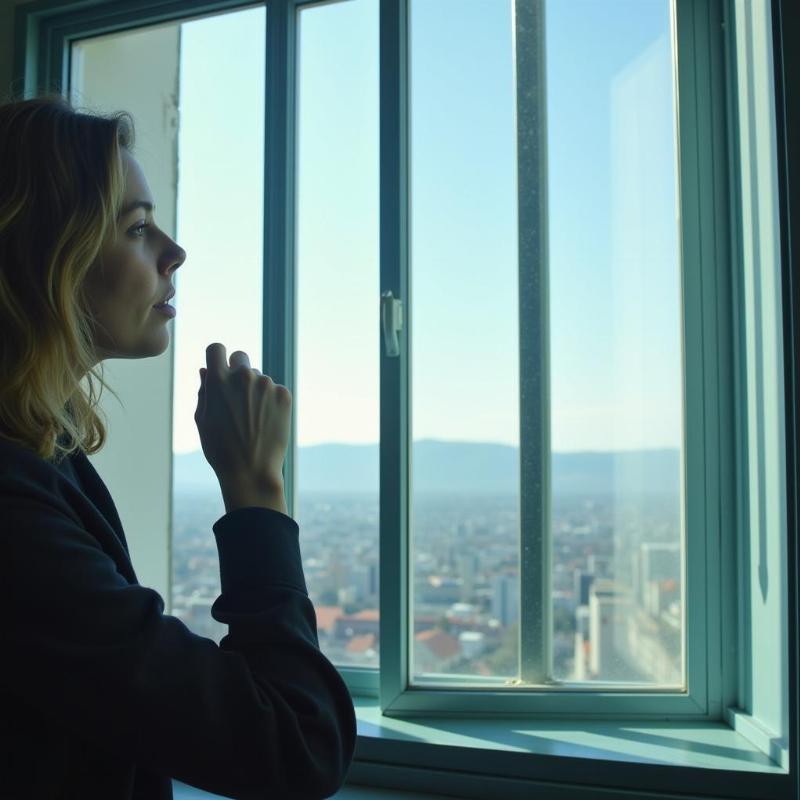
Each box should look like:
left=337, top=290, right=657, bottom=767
left=18, top=0, right=796, bottom=798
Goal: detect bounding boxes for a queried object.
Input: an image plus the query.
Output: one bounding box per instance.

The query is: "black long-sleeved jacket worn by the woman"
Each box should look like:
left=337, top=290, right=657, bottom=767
left=0, top=438, right=356, bottom=800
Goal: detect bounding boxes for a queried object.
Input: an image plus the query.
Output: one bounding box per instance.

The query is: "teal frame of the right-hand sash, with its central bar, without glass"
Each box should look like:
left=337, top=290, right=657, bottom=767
left=378, top=0, right=720, bottom=719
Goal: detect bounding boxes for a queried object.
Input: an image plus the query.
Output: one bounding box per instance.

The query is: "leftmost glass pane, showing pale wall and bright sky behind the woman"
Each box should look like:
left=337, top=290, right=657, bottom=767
left=71, top=6, right=266, bottom=643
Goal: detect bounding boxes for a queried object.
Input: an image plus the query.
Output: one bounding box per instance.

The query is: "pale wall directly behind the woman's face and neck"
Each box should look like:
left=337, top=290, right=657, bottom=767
left=71, top=24, right=180, bottom=612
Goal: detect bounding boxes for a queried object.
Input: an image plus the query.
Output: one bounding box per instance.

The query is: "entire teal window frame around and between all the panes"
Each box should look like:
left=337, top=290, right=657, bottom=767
left=14, top=0, right=800, bottom=798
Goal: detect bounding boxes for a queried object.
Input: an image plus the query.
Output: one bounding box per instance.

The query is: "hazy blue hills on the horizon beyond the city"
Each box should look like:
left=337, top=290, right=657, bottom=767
left=175, top=439, right=680, bottom=495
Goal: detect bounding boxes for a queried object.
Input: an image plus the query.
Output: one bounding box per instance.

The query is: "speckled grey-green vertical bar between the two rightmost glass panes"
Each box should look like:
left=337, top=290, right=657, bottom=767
left=514, top=0, right=552, bottom=684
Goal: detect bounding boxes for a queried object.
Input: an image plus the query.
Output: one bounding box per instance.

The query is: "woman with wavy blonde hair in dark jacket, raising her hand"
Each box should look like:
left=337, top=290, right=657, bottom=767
left=0, top=95, right=356, bottom=800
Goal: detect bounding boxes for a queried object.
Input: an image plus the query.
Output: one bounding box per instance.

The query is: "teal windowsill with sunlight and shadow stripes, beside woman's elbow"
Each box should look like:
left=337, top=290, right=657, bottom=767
left=350, top=696, right=789, bottom=800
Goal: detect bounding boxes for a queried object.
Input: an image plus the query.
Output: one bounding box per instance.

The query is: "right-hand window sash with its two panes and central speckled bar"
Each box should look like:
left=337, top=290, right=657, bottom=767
left=381, top=0, right=700, bottom=718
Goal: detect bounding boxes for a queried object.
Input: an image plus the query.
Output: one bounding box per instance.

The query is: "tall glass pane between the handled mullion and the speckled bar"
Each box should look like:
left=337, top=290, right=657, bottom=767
left=409, top=0, right=519, bottom=685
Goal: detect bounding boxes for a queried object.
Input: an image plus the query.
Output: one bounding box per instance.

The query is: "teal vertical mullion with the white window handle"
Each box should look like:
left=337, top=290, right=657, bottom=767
left=375, top=0, right=413, bottom=710
